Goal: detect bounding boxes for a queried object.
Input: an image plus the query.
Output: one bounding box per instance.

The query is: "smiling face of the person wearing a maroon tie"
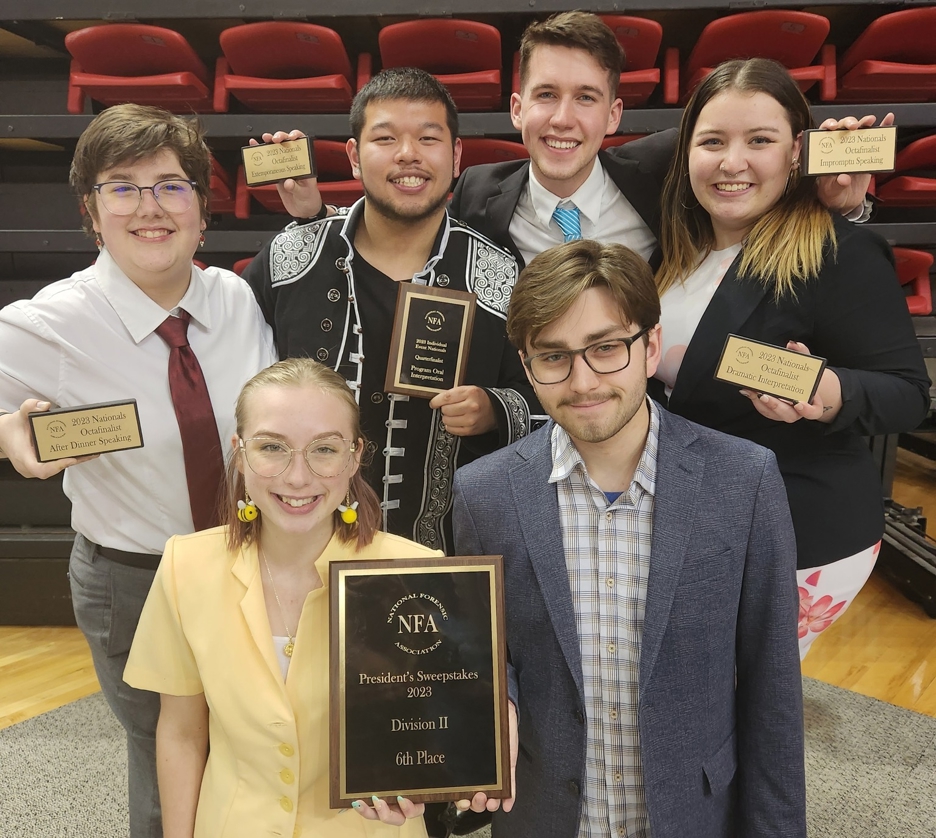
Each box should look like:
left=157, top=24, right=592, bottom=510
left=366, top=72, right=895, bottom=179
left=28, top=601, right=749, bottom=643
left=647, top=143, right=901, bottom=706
left=86, top=149, right=205, bottom=308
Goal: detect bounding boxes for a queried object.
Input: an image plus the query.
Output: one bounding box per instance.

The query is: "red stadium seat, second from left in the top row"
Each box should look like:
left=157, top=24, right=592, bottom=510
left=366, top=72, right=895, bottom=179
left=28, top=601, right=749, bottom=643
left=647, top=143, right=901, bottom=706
left=214, top=21, right=358, bottom=113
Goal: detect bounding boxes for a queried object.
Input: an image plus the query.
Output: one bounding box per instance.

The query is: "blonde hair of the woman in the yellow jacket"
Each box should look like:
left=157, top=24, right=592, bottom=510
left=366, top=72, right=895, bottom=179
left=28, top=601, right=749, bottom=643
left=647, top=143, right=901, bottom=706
left=221, top=358, right=380, bottom=551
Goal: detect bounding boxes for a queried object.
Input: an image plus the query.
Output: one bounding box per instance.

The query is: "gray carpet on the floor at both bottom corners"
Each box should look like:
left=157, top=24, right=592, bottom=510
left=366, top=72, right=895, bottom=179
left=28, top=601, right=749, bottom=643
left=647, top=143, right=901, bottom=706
left=0, top=678, right=936, bottom=838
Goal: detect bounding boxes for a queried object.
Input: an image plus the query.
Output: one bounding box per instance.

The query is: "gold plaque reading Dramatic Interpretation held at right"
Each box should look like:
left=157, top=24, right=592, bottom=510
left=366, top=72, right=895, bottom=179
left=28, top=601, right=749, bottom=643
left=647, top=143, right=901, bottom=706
left=715, top=335, right=826, bottom=402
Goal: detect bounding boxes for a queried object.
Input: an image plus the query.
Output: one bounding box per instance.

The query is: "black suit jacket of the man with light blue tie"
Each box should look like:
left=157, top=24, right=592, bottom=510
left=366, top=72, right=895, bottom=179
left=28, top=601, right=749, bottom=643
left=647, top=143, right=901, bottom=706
left=449, top=128, right=676, bottom=269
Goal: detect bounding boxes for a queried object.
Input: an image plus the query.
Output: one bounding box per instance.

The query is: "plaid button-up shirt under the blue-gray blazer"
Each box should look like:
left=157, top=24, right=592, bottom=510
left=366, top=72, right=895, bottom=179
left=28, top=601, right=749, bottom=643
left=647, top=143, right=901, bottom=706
left=549, top=399, right=660, bottom=838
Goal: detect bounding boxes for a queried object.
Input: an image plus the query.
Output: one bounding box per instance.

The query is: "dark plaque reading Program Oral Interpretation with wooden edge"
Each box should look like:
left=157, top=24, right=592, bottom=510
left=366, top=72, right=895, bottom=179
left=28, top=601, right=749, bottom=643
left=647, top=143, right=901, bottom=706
left=384, top=282, right=475, bottom=399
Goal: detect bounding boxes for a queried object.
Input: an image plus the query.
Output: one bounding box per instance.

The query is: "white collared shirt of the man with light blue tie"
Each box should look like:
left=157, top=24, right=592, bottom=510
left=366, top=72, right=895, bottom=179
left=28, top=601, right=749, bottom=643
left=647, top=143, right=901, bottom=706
left=508, top=158, right=656, bottom=265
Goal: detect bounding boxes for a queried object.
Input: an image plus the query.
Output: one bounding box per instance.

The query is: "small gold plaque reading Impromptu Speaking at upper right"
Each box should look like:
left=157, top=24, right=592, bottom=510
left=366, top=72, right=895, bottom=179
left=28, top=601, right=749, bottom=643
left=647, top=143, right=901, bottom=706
left=803, top=125, right=897, bottom=175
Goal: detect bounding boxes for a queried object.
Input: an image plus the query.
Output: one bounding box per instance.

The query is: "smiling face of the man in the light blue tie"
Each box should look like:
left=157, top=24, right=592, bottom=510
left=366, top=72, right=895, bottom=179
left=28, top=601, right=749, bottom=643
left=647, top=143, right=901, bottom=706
left=510, top=45, right=622, bottom=198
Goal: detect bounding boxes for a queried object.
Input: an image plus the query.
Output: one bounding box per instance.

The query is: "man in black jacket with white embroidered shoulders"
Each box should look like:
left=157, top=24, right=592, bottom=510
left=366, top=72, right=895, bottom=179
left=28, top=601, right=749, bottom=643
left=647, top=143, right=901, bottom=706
left=244, top=68, right=539, bottom=550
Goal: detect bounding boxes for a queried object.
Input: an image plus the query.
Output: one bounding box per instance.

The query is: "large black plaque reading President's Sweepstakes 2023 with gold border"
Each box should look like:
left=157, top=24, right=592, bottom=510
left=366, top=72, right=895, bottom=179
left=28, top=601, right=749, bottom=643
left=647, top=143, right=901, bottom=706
left=329, top=556, right=511, bottom=809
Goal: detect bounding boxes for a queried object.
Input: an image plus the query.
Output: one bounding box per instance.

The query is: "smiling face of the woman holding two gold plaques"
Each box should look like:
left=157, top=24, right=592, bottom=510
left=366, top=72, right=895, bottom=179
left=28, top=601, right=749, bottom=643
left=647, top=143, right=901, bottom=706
left=689, top=90, right=801, bottom=250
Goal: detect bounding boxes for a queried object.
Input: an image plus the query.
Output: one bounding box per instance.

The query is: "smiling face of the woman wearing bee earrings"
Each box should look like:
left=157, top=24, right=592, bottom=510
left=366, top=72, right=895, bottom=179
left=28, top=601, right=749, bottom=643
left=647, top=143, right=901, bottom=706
left=237, top=385, right=363, bottom=539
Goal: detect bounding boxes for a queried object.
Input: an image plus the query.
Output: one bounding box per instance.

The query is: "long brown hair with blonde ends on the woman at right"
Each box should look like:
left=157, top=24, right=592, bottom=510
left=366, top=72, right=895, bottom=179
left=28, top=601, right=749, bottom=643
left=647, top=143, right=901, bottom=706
left=656, top=58, right=837, bottom=299
